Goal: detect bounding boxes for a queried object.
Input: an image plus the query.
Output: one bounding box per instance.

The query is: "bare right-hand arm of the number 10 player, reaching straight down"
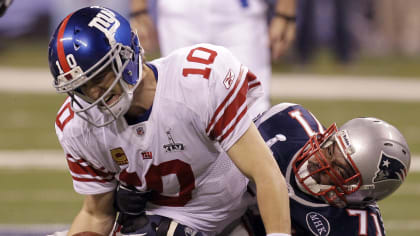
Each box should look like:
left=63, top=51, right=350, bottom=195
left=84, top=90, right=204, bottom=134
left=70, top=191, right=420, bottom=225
left=228, top=123, right=291, bottom=234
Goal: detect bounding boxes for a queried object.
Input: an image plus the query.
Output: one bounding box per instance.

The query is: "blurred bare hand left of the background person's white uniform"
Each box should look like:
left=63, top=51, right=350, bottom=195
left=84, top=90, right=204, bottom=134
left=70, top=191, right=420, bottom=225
left=130, top=13, right=159, bottom=53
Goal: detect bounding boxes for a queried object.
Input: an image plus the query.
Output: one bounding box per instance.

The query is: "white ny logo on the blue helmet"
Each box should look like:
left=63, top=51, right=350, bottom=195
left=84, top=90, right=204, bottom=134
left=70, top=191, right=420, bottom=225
left=89, top=7, right=120, bottom=45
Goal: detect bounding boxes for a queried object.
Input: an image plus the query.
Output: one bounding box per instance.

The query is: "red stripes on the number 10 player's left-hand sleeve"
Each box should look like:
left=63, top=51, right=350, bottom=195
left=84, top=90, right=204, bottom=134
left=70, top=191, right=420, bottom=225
left=67, top=154, right=114, bottom=182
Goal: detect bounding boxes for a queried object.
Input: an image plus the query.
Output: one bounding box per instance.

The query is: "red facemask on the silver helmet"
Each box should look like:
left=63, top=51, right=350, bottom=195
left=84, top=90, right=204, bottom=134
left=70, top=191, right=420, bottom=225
left=292, top=124, right=362, bottom=207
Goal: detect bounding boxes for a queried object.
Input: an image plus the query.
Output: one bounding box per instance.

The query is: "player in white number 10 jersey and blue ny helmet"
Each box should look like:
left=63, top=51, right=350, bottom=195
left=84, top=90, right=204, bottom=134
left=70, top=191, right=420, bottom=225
left=49, top=6, right=290, bottom=236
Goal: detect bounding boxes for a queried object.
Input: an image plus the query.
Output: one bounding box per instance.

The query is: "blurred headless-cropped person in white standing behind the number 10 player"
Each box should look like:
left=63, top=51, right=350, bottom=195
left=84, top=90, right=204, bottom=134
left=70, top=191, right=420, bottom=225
left=131, top=0, right=297, bottom=118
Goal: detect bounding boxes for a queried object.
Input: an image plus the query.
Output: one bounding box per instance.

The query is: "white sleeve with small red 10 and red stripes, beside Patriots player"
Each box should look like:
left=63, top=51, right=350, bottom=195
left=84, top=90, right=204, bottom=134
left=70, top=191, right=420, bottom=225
left=170, top=44, right=263, bottom=151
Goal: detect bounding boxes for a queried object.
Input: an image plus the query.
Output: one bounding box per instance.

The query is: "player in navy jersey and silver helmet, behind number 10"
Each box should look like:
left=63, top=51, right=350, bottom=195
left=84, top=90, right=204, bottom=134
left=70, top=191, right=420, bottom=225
left=248, top=103, right=410, bottom=236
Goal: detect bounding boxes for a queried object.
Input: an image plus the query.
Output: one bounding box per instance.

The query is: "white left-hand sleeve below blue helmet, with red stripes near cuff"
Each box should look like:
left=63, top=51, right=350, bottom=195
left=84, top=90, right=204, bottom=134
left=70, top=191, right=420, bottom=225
left=55, top=98, right=117, bottom=194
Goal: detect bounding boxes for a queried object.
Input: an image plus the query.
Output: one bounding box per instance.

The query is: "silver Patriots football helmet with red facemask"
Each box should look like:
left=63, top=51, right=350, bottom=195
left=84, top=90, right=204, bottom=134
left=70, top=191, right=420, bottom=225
left=292, top=118, right=411, bottom=207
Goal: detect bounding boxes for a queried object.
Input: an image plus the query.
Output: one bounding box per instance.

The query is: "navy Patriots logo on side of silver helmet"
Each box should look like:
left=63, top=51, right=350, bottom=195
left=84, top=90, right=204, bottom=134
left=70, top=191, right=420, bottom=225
left=373, top=152, right=407, bottom=183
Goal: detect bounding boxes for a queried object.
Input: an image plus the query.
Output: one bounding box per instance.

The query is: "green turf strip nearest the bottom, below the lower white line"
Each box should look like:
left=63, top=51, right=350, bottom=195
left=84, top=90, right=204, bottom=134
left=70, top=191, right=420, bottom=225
left=0, top=169, right=420, bottom=236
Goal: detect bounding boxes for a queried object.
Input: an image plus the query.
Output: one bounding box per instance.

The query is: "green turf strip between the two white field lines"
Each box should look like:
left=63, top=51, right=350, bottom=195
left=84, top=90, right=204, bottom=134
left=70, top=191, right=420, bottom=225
left=0, top=93, right=420, bottom=154
